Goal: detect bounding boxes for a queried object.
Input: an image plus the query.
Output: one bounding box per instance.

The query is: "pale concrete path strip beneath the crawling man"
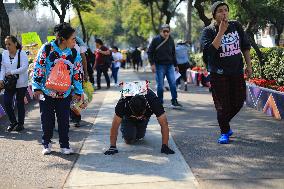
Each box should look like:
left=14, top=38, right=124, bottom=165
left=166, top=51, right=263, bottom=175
left=64, top=71, right=196, bottom=189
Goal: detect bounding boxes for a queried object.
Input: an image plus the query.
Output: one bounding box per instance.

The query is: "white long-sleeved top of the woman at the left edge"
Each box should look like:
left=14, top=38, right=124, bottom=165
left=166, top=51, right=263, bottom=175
left=0, top=50, right=29, bottom=88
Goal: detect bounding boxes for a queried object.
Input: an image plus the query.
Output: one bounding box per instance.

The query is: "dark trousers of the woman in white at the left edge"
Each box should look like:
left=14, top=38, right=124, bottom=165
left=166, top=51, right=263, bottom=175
left=4, top=87, right=27, bottom=125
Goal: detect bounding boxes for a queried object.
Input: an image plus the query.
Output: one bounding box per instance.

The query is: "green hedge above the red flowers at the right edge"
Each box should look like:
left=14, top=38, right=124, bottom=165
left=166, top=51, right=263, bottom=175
left=251, top=47, right=284, bottom=86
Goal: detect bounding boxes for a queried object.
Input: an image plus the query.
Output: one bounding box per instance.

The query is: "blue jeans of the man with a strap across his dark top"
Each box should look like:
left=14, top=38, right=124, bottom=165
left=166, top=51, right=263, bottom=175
left=155, top=64, right=177, bottom=103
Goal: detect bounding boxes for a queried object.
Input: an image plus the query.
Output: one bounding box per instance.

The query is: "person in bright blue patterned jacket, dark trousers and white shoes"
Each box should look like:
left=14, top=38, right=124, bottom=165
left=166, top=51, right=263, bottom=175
left=32, top=23, right=83, bottom=155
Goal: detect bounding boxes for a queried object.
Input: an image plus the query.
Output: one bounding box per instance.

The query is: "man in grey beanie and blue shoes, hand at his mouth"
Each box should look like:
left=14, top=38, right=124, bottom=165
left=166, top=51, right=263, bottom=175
left=201, top=1, right=252, bottom=144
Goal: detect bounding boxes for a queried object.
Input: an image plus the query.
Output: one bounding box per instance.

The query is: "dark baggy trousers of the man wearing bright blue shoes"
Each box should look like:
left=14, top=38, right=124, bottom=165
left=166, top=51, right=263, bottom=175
left=210, top=73, right=246, bottom=134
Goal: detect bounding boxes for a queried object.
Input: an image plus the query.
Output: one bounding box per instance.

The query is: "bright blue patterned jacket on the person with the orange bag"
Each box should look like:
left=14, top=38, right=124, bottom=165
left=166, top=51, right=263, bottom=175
left=32, top=41, right=83, bottom=98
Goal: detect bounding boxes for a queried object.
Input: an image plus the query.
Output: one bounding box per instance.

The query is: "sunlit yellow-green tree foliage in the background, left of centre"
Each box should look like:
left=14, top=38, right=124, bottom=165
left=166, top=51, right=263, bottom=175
left=71, top=0, right=152, bottom=46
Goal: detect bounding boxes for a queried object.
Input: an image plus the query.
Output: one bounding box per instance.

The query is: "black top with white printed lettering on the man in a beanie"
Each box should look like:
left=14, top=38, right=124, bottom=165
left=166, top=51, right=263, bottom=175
left=201, top=21, right=250, bottom=75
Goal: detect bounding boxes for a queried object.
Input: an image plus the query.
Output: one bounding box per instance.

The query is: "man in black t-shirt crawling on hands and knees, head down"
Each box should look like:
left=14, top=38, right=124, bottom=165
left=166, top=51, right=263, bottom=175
left=105, top=90, right=175, bottom=155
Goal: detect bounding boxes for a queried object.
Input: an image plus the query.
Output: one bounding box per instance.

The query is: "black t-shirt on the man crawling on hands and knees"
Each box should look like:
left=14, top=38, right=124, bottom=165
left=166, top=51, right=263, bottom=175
left=115, top=90, right=165, bottom=119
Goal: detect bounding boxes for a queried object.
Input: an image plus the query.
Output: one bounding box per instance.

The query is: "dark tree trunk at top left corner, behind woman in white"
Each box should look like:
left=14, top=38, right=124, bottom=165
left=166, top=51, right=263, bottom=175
left=0, top=1, right=10, bottom=48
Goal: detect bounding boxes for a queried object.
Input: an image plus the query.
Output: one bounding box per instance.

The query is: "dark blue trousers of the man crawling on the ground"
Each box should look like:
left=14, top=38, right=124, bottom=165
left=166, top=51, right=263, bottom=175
left=120, top=118, right=149, bottom=143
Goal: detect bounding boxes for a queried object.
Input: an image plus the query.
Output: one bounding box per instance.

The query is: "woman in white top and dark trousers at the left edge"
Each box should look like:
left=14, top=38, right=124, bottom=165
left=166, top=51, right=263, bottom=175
left=0, top=36, right=29, bottom=132
